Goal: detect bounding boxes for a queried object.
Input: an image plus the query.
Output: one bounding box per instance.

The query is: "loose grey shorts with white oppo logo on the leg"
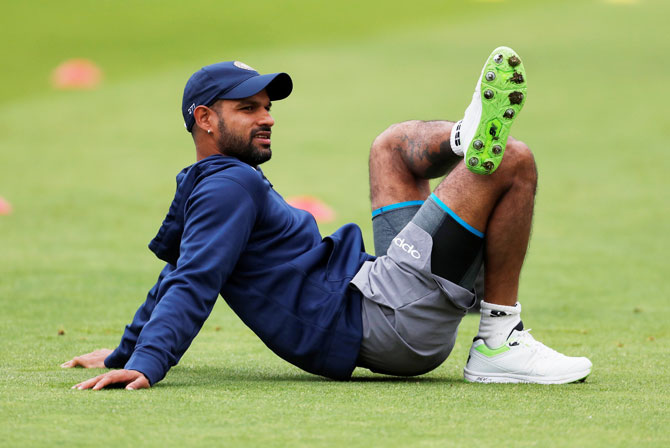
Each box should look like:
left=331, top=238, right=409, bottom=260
left=351, top=222, right=475, bottom=376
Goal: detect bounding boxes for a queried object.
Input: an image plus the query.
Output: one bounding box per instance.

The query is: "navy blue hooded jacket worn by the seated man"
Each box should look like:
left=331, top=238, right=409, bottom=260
left=105, top=155, right=373, bottom=384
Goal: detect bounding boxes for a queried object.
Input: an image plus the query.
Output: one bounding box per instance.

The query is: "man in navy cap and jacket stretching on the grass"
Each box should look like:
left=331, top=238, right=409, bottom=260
left=63, top=47, right=591, bottom=390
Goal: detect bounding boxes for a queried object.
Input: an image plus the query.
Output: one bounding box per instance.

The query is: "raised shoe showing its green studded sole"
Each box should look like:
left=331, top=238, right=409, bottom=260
left=450, top=47, right=526, bottom=174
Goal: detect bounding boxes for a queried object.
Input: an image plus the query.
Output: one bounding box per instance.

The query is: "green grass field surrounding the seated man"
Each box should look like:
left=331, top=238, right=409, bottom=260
left=0, top=0, right=670, bottom=447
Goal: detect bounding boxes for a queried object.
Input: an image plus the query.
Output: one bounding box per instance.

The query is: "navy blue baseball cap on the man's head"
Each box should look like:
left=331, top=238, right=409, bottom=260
left=181, top=61, right=293, bottom=132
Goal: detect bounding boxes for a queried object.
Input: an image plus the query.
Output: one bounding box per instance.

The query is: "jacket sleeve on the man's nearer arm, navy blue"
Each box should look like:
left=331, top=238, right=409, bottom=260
left=125, top=177, right=258, bottom=384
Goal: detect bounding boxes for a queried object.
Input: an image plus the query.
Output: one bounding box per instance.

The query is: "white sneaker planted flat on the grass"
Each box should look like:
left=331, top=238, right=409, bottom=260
left=463, top=329, right=592, bottom=384
